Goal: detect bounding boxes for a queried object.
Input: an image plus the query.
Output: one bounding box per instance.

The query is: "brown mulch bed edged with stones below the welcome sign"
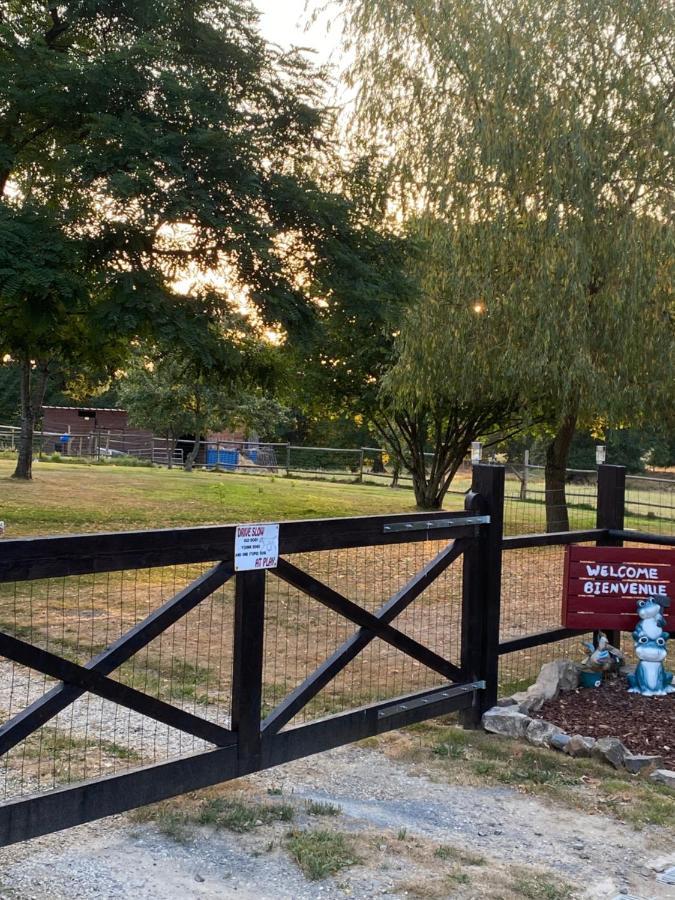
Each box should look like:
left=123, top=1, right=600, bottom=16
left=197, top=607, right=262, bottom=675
left=536, top=678, right=675, bottom=769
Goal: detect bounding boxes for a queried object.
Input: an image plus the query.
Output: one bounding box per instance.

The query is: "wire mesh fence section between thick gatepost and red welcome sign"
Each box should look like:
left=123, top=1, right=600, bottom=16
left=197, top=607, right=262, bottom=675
left=499, top=545, right=592, bottom=696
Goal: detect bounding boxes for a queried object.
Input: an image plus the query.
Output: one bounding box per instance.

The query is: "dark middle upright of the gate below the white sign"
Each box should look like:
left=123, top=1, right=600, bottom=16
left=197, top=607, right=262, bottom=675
left=232, top=570, right=265, bottom=774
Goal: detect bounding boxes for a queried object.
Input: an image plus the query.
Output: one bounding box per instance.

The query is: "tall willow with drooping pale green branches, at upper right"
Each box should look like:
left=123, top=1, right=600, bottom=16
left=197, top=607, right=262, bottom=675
left=340, top=0, right=675, bottom=530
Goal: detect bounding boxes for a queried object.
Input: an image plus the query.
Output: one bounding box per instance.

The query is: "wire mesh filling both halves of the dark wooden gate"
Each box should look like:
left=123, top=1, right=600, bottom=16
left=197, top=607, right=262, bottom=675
left=0, top=540, right=470, bottom=800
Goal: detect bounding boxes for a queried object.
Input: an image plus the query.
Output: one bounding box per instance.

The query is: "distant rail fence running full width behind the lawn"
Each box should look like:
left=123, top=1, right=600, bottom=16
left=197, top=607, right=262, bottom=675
left=0, top=425, right=675, bottom=535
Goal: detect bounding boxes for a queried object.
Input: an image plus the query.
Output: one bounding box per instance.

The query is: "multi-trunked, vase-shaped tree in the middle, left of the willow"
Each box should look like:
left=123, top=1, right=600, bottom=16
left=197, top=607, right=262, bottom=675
left=292, top=206, right=524, bottom=509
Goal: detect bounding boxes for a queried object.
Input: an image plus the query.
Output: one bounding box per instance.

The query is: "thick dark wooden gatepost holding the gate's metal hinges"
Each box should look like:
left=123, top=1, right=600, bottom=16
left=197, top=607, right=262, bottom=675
left=462, top=463, right=504, bottom=728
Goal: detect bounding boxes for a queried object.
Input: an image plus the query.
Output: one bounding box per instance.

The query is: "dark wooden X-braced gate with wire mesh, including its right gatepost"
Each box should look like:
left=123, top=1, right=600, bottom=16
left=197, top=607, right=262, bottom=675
left=0, top=466, right=504, bottom=845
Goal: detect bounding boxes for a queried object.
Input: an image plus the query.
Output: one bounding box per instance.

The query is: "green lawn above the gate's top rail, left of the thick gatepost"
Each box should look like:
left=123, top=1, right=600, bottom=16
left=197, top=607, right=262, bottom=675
left=0, top=459, right=430, bottom=538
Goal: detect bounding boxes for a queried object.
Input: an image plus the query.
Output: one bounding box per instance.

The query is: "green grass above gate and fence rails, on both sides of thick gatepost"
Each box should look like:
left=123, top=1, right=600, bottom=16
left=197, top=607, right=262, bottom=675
left=0, top=458, right=675, bottom=537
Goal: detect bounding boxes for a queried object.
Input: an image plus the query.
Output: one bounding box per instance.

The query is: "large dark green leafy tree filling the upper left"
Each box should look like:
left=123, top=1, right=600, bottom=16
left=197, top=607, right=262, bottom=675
left=0, top=0, right=394, bottom=478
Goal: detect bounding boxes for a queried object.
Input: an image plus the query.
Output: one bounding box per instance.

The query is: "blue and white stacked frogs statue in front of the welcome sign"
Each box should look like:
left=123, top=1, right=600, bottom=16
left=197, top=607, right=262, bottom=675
left=628, top=600, right=675, bottom=697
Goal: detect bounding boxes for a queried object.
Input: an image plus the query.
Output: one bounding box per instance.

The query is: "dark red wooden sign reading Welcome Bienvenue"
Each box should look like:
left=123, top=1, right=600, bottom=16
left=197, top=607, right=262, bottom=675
left=562, top=544, right=675, bottom=631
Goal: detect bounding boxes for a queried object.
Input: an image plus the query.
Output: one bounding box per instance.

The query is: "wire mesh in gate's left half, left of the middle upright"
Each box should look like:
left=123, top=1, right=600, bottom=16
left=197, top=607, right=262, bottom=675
left=0, top=564, right=234, bottom=799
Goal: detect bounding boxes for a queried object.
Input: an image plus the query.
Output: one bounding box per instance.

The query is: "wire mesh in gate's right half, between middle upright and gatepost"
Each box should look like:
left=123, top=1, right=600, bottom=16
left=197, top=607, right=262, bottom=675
left=263, top=541, right=462, bottom=725
